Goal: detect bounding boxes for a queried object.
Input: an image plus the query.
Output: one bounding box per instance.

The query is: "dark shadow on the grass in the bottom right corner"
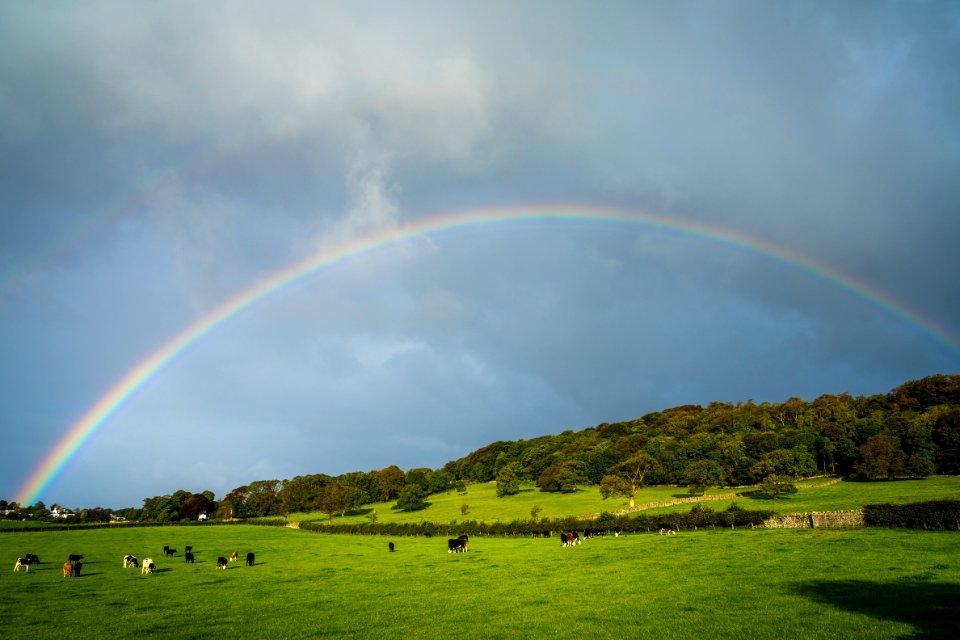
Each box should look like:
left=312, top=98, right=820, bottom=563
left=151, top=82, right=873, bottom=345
left=794, top=578, right=960, bottom=640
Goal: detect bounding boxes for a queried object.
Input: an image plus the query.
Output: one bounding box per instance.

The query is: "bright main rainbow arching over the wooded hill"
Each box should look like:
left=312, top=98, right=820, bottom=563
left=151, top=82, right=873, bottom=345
left=15, top=204, right=960, bottom=504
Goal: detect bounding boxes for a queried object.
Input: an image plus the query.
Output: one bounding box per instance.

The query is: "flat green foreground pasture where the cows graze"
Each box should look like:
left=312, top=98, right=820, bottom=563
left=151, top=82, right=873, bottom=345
left=0, top=525, right=960, bottom=640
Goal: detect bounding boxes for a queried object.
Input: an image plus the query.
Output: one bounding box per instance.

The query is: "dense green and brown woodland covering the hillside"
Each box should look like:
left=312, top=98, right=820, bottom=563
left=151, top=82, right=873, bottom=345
left=3, top=375, right=960, bottom=522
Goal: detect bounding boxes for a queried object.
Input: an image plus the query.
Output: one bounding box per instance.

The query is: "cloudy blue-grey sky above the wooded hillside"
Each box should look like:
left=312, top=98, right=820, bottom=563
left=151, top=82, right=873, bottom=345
left=0, top=0, right=960, bottom=508
